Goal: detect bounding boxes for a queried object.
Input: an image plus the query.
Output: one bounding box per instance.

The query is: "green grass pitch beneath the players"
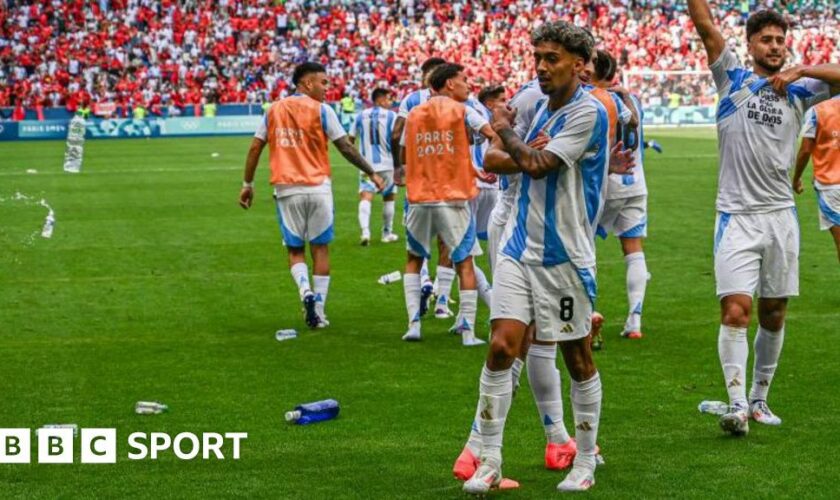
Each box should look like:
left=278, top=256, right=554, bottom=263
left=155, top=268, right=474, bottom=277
left=0, top=129, right=840, bottom=499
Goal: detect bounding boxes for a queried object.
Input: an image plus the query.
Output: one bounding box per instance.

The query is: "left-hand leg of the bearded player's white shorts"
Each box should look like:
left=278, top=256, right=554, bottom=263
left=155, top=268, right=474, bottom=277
left=714, top=213, right=763, bottom=298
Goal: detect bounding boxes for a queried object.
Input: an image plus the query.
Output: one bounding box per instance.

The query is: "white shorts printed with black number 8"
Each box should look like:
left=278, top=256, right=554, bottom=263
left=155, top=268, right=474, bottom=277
left=490, top=255, right=595, bottom=342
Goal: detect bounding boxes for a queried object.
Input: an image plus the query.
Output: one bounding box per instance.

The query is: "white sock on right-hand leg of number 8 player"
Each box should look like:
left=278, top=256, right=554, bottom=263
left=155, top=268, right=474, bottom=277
left=568, top=372, right=602, bottom=470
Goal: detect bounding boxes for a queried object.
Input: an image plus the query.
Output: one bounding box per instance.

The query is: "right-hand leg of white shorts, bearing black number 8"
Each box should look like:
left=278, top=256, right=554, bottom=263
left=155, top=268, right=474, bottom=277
left=527, top=264, right=595, bottom=342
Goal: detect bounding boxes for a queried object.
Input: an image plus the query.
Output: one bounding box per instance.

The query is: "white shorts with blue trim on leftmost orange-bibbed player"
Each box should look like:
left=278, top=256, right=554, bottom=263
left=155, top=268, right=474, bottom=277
left=275, top=193, right=334, bottom=248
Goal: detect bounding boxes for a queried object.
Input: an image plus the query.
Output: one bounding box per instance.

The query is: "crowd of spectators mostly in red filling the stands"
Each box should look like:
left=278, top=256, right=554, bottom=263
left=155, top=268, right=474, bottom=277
left=0, top=0, right=840, bottom=117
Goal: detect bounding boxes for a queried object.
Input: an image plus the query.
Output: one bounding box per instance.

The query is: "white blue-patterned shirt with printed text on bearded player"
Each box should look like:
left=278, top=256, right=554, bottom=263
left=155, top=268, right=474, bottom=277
left=709, top=49, right=830, bottom=214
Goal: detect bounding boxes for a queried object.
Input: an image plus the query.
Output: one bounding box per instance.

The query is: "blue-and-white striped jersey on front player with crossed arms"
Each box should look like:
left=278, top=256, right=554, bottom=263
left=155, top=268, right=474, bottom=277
left=500, top=87, right=609, bottom=272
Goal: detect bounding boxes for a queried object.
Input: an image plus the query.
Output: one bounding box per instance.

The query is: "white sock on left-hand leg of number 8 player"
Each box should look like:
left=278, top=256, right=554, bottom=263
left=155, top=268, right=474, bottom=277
left=478, top=365, right=512, bottom=466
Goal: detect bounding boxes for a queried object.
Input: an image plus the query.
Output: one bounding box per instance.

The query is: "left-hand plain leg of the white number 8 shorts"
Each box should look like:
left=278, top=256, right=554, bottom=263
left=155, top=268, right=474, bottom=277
left=490, top=257, right=534, bottom=325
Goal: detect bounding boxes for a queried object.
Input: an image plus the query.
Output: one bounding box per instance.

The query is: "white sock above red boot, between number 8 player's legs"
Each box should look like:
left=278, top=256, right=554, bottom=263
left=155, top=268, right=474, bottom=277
left=526, top=344, right=569, bottom=444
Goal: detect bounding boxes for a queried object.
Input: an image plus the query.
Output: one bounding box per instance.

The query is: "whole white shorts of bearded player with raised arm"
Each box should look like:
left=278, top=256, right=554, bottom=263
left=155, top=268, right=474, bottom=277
left=714, top=208, right=799, bottom=298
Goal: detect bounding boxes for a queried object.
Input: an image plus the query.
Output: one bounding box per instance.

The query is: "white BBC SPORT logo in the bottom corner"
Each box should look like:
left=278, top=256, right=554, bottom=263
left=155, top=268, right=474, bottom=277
left=0, top=428, right=248, bottom=464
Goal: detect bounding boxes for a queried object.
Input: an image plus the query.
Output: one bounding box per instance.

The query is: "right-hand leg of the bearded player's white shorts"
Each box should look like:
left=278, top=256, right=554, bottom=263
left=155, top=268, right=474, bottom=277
left=758, top=208, right=799, bottom=298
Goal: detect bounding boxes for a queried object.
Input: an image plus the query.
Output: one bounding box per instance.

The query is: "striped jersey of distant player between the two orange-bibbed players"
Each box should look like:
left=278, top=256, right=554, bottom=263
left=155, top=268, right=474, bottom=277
left=350, top=106, right=397, bottom=172
